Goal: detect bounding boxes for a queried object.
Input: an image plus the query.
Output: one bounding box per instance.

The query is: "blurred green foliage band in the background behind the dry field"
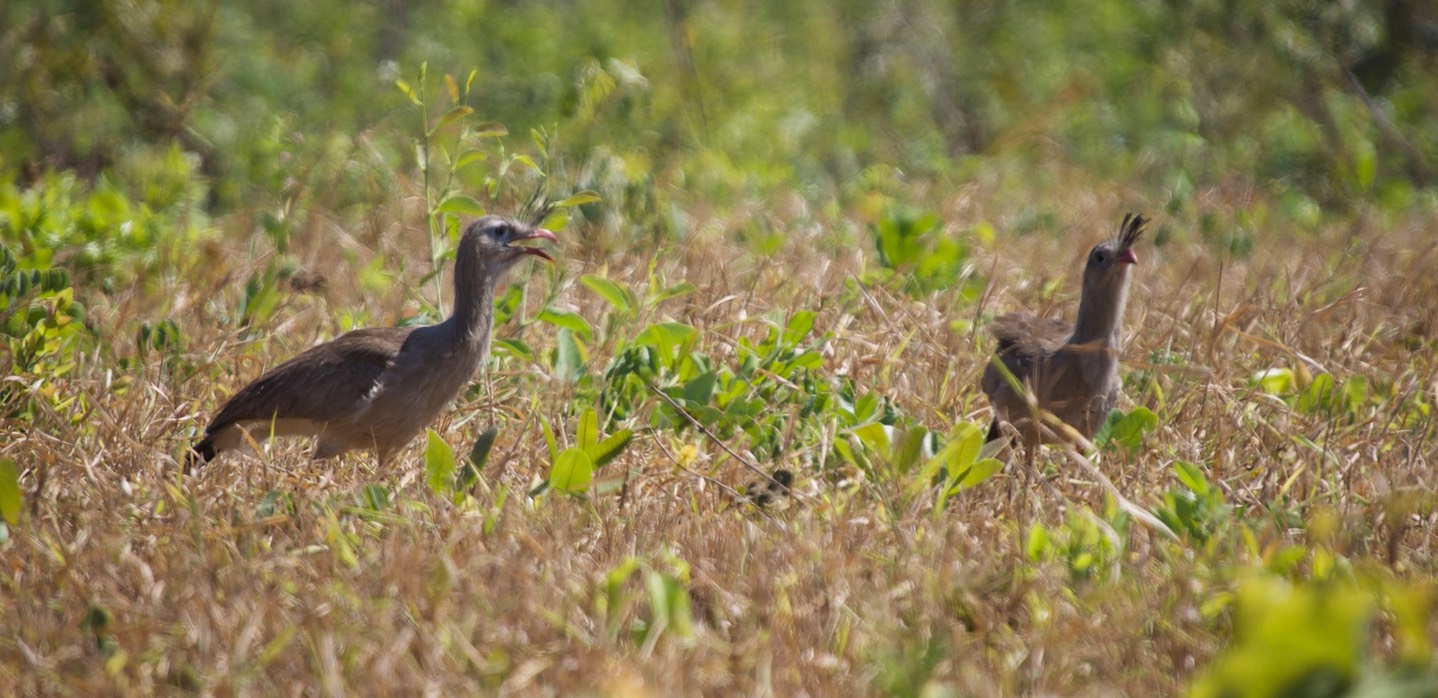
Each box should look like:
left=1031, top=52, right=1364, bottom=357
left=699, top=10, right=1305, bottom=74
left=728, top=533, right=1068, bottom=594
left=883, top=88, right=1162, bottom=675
left=0, top=0, right=1438, bottom=217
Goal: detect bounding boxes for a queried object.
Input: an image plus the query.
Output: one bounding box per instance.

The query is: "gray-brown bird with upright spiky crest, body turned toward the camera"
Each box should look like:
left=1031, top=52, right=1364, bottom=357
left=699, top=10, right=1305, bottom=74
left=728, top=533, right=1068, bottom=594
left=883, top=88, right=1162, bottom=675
left=982, top=213, right=1146, bottom=445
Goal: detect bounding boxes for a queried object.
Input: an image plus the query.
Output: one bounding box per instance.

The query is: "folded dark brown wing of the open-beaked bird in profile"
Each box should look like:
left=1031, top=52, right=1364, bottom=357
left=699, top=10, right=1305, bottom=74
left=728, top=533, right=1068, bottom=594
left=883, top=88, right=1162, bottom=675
left=206, top=327, right=414, bottom=435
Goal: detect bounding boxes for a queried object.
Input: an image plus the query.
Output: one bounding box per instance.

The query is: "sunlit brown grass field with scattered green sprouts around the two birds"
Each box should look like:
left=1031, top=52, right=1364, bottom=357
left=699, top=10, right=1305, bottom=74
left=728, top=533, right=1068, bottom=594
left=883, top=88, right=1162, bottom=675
left=0, top=159, right=1438, bottom=695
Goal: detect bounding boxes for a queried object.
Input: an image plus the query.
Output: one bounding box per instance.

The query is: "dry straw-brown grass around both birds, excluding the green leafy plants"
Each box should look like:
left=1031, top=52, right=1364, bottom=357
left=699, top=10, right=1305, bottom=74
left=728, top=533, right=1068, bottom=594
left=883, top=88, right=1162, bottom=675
left=0, top=175, right=1438, bottom=695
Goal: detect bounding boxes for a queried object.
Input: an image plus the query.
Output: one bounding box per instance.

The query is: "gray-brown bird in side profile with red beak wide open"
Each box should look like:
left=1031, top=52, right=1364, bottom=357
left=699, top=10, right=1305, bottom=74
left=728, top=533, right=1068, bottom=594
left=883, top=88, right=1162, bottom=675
left=186, top=216, right=555, bottom=471
